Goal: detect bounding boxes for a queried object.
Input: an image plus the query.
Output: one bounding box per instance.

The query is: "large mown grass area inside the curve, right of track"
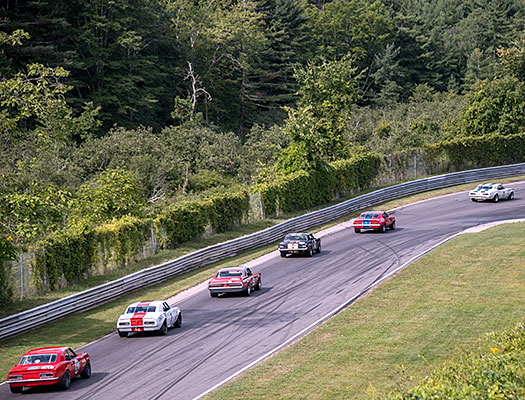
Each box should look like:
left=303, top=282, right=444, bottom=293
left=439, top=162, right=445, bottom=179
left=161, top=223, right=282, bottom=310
left=206, top=223, right=525, bottom=400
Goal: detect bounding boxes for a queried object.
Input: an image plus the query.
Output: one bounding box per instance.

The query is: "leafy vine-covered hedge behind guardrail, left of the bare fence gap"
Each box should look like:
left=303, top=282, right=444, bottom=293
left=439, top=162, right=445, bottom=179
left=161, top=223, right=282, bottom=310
left=32, top=190, right=250, bottom=290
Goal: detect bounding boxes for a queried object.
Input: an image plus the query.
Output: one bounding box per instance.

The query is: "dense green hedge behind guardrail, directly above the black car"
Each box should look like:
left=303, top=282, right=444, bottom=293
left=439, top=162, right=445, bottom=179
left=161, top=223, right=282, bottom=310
left=257, top=154, right=381, bottom=216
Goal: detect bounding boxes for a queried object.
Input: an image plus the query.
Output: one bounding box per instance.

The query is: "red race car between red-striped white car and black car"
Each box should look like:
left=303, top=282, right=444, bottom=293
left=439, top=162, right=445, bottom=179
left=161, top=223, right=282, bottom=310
left=208, top=265, right=262, bottom=297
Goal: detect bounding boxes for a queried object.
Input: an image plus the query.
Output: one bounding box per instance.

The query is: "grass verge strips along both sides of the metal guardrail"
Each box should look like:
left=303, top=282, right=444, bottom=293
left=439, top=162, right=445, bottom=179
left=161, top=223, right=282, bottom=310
left=0, top=177, right=523, bottom=380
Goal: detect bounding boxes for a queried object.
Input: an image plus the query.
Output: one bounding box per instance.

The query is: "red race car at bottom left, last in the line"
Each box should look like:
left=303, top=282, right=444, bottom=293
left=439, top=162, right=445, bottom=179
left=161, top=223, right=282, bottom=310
left=7, top=347, right=91, bottom=393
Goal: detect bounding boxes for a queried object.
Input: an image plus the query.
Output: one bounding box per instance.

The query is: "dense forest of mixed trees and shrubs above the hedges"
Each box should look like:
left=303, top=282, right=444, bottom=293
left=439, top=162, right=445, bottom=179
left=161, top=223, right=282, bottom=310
left=0, top=0, right=525, bottom=300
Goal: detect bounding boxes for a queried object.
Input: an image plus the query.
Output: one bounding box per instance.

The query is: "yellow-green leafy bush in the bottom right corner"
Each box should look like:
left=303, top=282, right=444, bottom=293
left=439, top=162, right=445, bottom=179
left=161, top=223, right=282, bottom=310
left=380, top=320, right=525, bottom=400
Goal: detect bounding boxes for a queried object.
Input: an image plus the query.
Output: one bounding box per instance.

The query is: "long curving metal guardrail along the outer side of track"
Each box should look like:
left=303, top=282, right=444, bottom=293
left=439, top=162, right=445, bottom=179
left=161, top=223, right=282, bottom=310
left=0, top=163, right=525, bottom=339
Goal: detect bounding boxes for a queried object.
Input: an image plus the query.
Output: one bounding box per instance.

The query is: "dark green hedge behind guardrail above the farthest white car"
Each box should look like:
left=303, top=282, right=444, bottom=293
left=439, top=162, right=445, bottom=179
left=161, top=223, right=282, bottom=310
left=424, top=133, right=525, bottom=171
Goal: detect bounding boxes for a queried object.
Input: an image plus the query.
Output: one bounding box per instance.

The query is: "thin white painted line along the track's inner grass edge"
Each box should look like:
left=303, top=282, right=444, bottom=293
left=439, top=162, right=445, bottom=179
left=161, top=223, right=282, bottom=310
left=193, top=232, right=463, bottom=400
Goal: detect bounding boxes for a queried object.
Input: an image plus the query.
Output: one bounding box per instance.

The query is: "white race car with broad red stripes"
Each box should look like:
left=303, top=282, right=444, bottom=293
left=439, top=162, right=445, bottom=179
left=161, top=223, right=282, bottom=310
left=117, top=300, right=182, bottom=337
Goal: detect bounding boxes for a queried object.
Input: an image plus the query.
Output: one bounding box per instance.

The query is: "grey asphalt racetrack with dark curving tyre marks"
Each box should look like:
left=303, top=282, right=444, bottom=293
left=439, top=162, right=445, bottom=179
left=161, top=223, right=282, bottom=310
left=4, top=182, right=525, bottom=400
